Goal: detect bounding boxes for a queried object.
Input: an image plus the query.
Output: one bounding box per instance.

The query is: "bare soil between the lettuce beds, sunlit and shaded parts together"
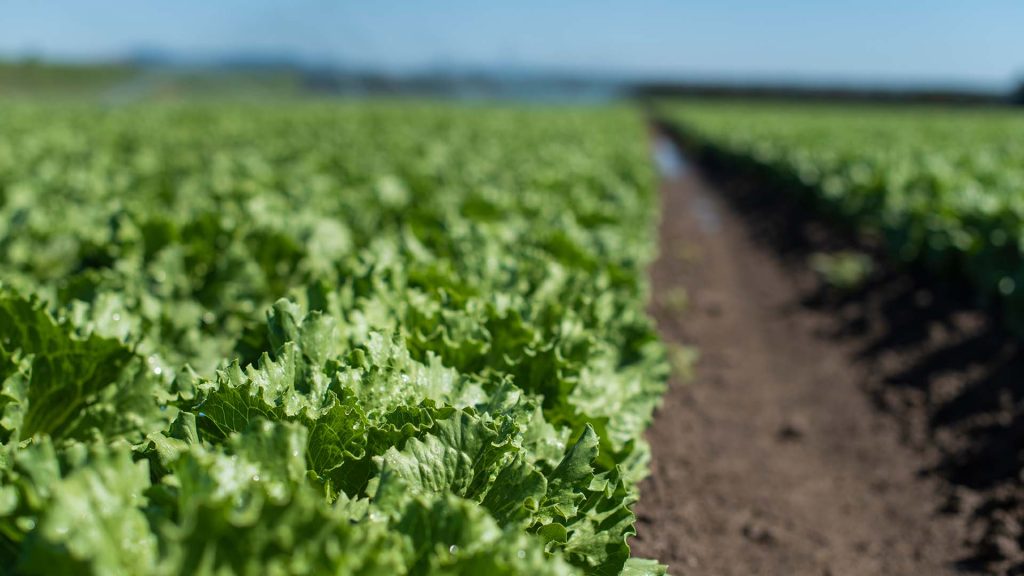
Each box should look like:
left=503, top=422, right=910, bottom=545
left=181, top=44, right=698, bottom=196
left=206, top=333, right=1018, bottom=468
left=632, top=130, right=1024, bottom=575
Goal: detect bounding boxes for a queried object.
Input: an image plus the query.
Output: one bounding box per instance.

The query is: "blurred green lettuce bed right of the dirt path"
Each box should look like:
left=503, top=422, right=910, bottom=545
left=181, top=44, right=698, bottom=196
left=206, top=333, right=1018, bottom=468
left=659, top=101, right=1024, bottom=334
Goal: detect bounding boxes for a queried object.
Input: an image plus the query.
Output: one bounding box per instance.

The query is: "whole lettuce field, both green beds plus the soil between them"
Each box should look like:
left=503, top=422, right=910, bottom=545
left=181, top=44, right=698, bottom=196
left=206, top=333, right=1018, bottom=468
left=8, top=94, right=1024, bottom=576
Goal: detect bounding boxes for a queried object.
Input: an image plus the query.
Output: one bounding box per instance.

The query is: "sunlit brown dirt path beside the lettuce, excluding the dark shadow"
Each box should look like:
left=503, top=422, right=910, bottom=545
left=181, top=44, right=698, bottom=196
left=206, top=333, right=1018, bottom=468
left=633, top=131, right=965, bottom=576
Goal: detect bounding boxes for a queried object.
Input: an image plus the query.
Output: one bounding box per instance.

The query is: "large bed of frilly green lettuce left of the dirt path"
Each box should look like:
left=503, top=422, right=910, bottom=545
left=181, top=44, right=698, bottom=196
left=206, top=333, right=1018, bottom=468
left=0, top=104, right=667, bottom=575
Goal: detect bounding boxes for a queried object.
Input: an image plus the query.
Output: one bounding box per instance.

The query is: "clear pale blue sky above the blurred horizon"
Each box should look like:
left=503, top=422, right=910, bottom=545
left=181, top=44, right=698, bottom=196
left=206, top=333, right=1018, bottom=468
left=0, top=0, right=1024, bottom=87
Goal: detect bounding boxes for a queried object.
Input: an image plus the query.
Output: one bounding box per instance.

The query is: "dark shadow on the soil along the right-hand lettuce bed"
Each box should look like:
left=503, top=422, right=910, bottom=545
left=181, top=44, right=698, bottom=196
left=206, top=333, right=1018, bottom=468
left=658, top=124, right=1024, bottom=574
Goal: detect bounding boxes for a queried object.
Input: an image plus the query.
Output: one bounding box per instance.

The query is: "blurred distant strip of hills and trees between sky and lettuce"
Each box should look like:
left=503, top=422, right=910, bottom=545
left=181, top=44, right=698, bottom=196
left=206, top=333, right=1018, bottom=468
left=0, top=53, right=1024, bottom=106
